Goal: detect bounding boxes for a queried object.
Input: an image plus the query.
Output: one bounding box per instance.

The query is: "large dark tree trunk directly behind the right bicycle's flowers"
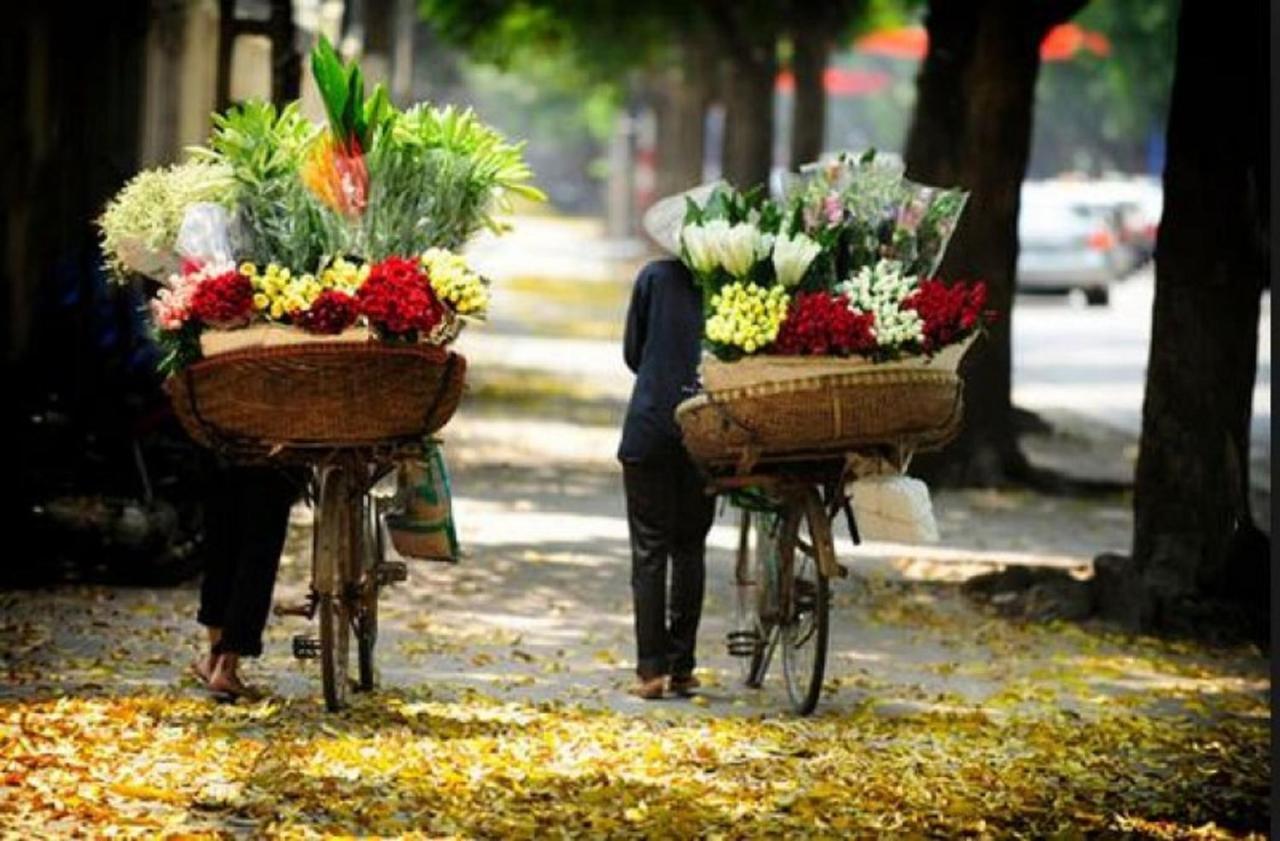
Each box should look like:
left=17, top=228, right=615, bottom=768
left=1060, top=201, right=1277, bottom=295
left=906, top=0, right=1083, bottom=485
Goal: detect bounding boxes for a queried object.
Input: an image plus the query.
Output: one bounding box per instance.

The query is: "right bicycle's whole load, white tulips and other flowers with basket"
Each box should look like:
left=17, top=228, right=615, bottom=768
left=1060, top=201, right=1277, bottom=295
left=677, top=154, right=992, bottom=469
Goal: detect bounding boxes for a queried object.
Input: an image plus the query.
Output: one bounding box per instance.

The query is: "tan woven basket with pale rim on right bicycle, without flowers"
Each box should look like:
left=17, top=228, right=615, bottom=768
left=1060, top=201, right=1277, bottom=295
left=676, top=345, right=963, bottom=470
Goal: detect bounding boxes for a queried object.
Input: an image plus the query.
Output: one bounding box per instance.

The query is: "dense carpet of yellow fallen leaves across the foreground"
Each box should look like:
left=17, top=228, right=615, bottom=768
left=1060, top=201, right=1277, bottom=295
left=0, top=675, right=1268, bottom=838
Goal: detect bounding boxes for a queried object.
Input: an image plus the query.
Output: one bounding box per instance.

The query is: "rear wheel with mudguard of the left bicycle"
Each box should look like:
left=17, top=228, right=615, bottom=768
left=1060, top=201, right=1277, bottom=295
left=312, top=466, right=360, bottom=712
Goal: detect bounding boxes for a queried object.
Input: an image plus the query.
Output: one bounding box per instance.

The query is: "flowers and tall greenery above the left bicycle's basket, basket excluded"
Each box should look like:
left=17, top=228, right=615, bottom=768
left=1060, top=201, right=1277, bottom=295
left=100, top=38, right=545, bottom=371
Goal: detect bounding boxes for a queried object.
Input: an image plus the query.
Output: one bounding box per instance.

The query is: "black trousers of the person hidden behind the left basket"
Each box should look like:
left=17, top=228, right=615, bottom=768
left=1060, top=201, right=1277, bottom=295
left=196, top=467, right=301, bottom=657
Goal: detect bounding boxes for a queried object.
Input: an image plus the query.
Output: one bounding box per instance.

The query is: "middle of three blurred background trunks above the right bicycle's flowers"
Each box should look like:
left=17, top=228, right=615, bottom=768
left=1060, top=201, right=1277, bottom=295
left=723, top=41, right=778, bottom=189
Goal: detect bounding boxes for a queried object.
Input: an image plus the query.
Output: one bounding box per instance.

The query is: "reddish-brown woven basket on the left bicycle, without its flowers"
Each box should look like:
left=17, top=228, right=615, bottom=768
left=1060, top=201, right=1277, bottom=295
left=165, top=342, right=466, bottom=451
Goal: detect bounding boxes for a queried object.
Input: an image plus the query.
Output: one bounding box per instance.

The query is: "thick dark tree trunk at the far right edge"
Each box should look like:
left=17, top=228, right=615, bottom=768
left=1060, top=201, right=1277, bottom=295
left=1101, top=0, right=1270, bottom=634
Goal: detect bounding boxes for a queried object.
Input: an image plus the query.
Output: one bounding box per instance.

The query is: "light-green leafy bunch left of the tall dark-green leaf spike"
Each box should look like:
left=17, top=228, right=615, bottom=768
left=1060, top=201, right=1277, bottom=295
left=195, top=100, right=352, bottom=270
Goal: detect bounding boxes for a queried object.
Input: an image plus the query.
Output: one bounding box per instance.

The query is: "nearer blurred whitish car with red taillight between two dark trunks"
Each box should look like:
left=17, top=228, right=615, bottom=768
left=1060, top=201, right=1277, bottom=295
left=1018, top=182, right=1134, bottom=306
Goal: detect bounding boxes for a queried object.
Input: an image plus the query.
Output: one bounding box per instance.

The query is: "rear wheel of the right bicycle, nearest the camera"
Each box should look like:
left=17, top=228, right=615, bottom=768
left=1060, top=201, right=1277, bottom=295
left=778, top=488, right=835, bottom=716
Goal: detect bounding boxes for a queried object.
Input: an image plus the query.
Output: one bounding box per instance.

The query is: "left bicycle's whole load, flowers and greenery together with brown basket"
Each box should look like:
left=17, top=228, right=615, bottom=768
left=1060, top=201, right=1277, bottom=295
left=100, top=38, right=543, bottom=447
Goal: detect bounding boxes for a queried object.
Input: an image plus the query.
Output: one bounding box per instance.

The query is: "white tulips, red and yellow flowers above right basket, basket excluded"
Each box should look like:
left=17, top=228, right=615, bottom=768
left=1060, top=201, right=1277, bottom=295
left=678, top=152, right=993, bottom=361
